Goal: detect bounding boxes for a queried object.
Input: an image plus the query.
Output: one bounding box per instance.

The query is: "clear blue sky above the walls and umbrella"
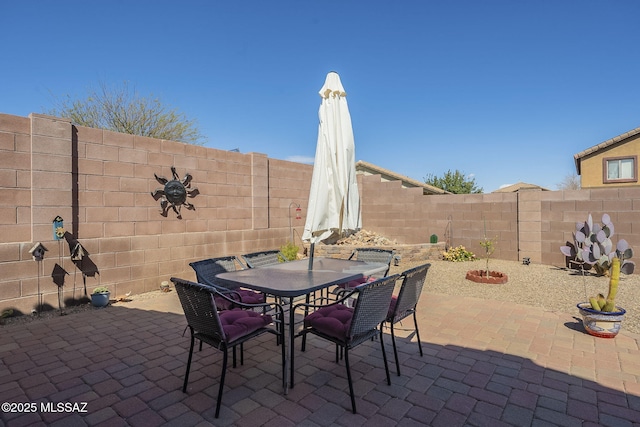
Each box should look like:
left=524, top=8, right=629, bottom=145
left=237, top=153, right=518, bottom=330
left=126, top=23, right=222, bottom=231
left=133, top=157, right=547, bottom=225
left=0, top=0, right=640, bottom=192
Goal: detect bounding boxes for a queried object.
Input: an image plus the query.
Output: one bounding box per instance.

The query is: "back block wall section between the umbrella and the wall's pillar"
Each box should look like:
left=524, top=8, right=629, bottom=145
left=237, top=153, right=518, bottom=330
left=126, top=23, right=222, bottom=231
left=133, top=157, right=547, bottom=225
left=359, top=175, right=518, bottom=260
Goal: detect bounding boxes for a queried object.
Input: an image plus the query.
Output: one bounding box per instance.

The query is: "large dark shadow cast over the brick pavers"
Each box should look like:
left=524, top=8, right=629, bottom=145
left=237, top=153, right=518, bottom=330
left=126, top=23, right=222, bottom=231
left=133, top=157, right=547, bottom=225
left=0, top=297, right=640, bottom=426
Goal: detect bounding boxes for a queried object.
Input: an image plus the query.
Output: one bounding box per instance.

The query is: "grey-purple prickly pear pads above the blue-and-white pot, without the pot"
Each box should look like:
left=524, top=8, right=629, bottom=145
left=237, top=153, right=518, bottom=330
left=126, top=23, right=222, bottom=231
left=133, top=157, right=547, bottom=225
left=560, top=214, right=635, bottom=276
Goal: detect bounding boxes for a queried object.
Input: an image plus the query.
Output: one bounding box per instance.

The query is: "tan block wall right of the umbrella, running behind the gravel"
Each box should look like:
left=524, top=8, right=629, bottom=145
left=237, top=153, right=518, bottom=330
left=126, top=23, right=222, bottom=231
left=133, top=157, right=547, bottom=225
left=359, top=171, right=640, bottom=272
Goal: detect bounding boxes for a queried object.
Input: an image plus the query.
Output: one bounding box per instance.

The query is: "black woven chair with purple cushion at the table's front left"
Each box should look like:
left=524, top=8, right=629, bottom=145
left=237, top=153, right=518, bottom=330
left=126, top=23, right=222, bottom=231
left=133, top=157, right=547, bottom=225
left=171, top=277, right=286, bottom=418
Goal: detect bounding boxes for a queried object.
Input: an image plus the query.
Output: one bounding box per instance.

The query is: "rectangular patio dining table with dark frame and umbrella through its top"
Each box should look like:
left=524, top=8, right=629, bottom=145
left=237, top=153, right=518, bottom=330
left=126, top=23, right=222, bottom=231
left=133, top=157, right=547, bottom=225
left=216, top=258, right=388, bottom=393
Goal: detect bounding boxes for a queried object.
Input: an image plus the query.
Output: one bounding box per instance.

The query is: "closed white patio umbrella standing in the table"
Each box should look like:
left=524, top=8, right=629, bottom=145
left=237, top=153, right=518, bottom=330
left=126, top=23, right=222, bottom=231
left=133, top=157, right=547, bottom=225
left=302, top=72, right=362, bottom=267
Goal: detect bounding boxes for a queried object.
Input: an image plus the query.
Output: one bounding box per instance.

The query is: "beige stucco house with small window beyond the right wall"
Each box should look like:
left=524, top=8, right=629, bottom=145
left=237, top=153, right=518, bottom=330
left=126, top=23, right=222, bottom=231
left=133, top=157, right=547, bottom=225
left=573, top=128, right=640, bottom=189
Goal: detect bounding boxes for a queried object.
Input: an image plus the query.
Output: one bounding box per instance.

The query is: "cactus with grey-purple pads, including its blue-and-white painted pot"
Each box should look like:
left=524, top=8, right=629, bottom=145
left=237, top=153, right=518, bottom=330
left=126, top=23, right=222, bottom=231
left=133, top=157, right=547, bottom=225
left=560, top=214, right=635, bottom=338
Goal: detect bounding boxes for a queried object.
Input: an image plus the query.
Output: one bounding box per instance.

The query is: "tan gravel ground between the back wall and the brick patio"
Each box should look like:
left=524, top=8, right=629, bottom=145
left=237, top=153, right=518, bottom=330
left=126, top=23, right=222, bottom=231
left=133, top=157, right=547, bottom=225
left=390, top=260, right=640, bottom=334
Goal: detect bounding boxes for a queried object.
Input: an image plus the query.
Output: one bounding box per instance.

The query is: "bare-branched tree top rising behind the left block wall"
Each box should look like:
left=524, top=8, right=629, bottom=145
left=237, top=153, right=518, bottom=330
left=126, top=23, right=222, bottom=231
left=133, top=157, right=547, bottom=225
left=46, top=82, right=206, bottom=145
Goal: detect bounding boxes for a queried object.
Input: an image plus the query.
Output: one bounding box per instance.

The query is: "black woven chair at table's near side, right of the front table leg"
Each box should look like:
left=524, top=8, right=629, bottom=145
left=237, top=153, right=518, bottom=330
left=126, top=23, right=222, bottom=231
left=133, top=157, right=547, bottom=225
left=291, top=275, right=399, bottom=414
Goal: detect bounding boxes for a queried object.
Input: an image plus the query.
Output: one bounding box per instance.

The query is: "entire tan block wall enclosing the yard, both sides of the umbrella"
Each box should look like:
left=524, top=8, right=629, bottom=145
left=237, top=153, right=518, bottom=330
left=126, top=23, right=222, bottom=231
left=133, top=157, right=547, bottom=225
left=0, top=114, right=640, bottom=313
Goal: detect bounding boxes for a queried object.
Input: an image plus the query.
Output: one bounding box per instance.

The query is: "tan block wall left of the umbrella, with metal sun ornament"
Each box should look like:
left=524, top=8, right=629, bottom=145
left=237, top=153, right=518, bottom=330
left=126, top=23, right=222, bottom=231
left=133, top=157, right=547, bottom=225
left=0, top=114, right=312, bottom=313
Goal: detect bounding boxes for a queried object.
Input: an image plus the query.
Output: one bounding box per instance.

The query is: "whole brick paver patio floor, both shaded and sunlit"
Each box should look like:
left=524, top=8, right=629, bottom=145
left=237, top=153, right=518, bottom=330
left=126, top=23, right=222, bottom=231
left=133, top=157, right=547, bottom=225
left=0, top=292, right=640, bottom=427
